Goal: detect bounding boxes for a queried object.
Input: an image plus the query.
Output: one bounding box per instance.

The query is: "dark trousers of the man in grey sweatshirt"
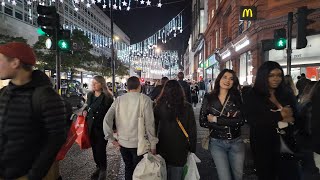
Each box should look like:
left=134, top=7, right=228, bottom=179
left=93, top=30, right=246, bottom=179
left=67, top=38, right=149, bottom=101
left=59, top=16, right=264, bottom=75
left=120, top=146, right=143, bottom=180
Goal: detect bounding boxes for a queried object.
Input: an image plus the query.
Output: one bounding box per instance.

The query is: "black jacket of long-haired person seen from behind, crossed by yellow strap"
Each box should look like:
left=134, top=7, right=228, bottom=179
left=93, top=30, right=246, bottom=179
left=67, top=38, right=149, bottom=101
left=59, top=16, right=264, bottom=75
left=154, top=103, right=197, bottom=167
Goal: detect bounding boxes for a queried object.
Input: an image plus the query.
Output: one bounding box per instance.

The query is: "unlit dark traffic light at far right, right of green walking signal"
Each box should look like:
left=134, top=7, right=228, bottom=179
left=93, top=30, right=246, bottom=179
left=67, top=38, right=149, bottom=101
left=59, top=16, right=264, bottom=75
left=296, top=6, right=315, bottom=49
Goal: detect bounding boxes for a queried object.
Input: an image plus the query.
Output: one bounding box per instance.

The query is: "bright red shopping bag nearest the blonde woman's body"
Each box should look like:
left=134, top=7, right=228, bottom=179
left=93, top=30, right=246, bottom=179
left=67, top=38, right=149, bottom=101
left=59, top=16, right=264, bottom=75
left=75, top=115, right=91, bottom=149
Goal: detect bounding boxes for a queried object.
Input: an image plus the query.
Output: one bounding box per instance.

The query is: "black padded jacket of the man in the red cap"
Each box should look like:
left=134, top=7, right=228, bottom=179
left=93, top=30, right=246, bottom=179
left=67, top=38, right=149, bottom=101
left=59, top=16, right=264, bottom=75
left=0, top=71, right=67, bottom=180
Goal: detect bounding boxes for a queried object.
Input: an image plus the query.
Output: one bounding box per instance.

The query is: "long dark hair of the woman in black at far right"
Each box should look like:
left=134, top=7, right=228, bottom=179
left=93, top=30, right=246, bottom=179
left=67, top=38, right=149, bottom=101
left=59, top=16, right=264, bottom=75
left=253, top=61, right=286, bottom=98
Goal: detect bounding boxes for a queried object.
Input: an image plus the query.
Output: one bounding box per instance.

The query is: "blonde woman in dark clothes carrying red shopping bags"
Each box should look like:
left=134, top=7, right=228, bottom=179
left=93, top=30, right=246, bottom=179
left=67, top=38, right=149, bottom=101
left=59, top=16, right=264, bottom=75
left=84, top=76, right=113, bottom=180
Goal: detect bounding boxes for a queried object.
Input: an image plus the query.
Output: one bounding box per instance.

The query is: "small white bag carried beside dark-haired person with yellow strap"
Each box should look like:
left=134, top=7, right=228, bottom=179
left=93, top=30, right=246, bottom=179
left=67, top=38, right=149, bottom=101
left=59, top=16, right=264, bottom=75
left=183, top=153, right=201, bottom=180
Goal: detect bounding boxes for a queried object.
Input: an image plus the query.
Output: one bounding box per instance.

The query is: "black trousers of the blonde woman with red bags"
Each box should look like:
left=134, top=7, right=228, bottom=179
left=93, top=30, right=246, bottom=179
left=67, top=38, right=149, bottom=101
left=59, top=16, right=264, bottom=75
left=90, top=128, right=108, bottom=170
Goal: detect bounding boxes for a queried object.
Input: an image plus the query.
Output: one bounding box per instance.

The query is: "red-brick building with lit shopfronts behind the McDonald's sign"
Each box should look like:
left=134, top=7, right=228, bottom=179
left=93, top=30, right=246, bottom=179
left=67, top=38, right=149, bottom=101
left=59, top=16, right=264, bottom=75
left=204, top=0, right=320, bottom=84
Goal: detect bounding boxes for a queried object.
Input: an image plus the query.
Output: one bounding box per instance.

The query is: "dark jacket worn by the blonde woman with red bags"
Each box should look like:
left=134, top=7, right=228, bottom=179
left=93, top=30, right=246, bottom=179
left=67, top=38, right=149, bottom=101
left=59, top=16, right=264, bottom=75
left=85, top=92, right=113, bottom=135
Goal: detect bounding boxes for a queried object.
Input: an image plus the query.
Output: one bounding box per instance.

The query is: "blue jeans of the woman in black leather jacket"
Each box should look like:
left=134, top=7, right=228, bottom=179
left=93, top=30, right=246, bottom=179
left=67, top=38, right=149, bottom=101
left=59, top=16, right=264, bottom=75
left=209, top=137, right=245, bottom=180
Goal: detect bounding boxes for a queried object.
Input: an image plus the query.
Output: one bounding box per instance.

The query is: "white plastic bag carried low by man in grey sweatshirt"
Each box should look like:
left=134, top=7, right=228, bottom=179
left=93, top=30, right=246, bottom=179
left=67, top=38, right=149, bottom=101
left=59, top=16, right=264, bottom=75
left=132, top=153, right=167, bottom=180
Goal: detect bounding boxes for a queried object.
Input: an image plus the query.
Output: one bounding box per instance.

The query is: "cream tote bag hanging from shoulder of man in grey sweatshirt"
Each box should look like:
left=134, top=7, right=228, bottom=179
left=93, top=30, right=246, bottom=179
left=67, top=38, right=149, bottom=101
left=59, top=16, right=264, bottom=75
left=137, top=94, right=151, bottom=156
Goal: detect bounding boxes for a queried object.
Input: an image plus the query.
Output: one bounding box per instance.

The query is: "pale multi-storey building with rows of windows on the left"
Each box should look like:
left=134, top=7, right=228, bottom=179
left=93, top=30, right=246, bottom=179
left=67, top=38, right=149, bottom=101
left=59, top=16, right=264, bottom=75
left=0, top=0, right=130, bottom=86
